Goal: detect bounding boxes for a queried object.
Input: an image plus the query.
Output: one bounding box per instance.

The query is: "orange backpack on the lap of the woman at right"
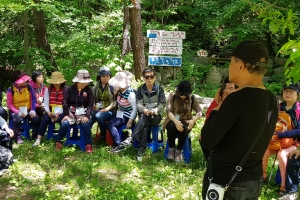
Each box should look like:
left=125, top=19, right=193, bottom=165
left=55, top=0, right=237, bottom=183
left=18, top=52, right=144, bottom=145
left=268, top=111, right=294, bottom=151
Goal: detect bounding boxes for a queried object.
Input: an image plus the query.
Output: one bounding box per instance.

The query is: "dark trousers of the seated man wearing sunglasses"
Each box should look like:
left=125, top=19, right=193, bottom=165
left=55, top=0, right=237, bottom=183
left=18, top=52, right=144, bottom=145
left=132, top=114, right=161, bottom=147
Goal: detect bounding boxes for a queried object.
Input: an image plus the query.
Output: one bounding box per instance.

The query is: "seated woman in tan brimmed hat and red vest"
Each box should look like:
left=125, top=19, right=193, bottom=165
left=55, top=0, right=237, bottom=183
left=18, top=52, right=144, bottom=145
left=33, top=72, right=66, bottom=146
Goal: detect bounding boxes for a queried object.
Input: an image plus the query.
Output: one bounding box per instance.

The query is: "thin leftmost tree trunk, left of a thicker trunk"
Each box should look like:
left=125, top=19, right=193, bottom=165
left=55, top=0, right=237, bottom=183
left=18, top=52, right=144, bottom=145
left=22, top=10, right=31, bottom=74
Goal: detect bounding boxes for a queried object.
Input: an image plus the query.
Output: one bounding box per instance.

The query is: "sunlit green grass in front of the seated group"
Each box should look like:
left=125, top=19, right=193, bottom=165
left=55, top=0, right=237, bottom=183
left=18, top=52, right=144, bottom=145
left=0, top=120, right=284, bottom=200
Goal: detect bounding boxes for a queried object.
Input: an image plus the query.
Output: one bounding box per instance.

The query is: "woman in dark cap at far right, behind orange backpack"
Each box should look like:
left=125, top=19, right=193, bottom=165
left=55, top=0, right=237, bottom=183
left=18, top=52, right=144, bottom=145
left=263, top=84, right=300, bottom=196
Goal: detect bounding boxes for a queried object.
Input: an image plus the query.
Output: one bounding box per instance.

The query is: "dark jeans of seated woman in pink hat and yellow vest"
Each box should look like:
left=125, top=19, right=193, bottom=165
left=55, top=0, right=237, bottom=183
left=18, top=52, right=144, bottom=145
left=9, top=111, right=41, bottom=139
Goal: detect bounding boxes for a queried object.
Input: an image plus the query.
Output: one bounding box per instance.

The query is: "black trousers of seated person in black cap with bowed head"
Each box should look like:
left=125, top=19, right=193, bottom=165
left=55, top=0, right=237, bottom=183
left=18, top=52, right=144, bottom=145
left=166, top=121, right=190, bottom=150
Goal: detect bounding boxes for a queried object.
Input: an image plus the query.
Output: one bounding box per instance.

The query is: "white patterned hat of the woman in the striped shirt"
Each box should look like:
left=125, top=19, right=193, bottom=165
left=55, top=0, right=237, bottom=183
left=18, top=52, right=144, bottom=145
left=108, top=71, right=134, bottom=88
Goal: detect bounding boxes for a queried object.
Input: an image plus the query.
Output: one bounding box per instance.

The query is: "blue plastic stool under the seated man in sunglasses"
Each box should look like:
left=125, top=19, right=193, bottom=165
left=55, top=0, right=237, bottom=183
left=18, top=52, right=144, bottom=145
left=148, top=125, right=165, bottom=153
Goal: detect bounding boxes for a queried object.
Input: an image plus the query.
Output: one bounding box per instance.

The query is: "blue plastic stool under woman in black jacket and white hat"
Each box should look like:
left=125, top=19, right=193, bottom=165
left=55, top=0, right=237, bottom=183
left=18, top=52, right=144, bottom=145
left=65, top=124, right=85, bottom=151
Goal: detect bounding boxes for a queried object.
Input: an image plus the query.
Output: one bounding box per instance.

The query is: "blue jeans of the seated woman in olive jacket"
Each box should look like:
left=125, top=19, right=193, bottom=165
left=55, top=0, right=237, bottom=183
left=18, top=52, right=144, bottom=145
left=91, top=111, right=116, bottom=133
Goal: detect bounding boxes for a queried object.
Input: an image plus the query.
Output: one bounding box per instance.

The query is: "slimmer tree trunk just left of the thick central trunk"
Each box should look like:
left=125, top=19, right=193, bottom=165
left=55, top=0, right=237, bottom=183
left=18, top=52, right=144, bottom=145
left=121, top=5, right=131, bottom=58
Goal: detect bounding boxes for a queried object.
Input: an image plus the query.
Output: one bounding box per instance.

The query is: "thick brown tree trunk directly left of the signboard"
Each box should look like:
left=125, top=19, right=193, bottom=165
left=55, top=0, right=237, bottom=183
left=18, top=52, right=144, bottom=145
left=129, top=0, right=146, bottom=79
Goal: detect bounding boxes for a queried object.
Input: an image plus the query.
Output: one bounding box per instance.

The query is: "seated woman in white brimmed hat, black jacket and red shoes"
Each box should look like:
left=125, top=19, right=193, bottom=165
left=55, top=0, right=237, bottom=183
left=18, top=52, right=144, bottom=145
left=56, top=70, right=94, bottom=153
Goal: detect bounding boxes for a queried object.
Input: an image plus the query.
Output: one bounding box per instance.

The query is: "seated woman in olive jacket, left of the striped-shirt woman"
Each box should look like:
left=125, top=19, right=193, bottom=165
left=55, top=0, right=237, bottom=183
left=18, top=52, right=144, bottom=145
left=91, top=66, right=116, bottom=140
